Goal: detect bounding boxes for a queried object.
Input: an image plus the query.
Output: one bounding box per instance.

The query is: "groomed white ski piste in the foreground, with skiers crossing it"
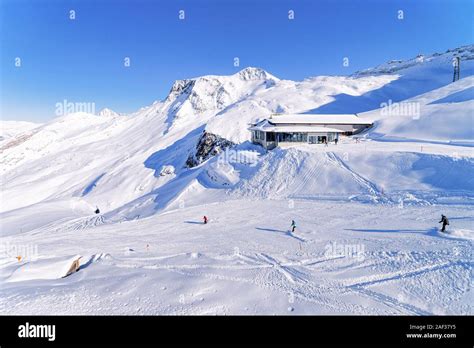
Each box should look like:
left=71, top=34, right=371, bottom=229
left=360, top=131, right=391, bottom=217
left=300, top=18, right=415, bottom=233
left=0, top=200, right=474, bottom=315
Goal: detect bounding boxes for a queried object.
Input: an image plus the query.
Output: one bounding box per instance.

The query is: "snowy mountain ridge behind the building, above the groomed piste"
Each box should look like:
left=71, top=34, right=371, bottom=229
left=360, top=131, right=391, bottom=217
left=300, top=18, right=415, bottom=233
left=0, top=43, right=473, bottom=219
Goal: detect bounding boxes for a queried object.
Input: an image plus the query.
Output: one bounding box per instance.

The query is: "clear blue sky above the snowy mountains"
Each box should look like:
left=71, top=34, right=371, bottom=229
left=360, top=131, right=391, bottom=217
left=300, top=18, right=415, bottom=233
left=0, top=0, right=474, bottom=122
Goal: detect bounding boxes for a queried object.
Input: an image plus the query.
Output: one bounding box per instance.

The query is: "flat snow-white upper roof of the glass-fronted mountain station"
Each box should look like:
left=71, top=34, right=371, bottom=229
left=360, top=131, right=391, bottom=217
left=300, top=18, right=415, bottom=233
left=269, top=114, right=372, bottom=125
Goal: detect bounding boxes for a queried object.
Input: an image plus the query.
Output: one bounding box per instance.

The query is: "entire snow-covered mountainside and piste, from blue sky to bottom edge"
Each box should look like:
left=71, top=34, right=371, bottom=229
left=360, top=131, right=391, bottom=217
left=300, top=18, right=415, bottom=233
left=0, top=46, right=474, bottom=314
